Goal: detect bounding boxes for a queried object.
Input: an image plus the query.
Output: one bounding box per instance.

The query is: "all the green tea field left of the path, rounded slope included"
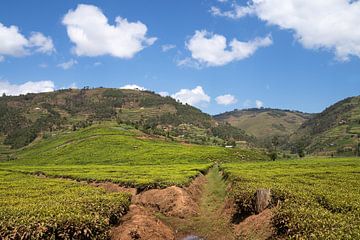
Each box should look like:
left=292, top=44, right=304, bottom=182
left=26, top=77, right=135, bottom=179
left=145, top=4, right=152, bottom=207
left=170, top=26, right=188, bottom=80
left=0, top=123, right=264, bottom=239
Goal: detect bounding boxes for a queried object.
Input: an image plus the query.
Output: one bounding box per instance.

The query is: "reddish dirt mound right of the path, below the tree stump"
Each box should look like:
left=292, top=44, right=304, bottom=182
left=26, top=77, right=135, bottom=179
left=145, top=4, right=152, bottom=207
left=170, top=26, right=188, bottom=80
left=235, top=209, right=274, bottom=239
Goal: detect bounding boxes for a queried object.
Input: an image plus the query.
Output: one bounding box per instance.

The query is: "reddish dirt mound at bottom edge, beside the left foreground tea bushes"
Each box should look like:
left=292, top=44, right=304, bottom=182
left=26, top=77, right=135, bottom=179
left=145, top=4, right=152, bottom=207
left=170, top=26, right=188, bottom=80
left=111, top=205, right=175, bottom=240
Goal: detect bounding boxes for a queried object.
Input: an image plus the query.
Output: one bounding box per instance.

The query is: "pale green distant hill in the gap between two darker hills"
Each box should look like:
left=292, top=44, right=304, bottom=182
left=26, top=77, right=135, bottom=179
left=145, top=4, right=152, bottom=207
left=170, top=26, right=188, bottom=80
left=214, top=108, right=312, bottom=141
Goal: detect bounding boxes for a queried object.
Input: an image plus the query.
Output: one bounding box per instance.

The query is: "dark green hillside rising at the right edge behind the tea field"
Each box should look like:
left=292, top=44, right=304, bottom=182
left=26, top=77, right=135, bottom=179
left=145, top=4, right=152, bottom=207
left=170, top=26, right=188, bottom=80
left=290, top=96, right=360, bottom=155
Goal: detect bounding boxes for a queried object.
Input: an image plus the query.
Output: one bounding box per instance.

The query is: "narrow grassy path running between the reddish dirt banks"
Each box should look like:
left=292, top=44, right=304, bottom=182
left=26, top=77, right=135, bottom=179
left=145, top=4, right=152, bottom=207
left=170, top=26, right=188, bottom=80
left=158, top=166, right=235, bottom=240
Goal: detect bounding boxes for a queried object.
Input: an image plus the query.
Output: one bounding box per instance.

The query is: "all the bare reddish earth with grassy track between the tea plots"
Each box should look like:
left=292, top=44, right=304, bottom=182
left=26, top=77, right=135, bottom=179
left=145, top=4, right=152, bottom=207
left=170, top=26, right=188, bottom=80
left=109, top=169, right=274, bottom=240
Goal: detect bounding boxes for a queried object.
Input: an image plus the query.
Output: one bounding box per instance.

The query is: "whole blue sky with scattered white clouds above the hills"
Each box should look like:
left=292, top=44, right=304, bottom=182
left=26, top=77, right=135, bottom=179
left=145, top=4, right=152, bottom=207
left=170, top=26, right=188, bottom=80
left=0, top=0, right=360, bottom=114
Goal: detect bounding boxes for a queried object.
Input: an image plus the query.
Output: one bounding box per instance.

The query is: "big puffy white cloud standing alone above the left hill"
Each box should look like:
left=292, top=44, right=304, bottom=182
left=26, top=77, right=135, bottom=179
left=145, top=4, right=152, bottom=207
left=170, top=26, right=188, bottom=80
left=62, top=4, right=156, bottom=58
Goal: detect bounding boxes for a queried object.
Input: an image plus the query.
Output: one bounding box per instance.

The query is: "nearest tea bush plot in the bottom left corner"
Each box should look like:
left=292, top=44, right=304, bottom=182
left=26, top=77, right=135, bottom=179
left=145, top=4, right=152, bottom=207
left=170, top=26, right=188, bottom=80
left=0, top=171, right=130, bottom=239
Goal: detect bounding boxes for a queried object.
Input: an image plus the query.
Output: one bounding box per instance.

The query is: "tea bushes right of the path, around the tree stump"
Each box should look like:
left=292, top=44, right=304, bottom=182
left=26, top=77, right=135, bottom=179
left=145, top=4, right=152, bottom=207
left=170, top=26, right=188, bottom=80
left=222, top=158, right=360, bottom=239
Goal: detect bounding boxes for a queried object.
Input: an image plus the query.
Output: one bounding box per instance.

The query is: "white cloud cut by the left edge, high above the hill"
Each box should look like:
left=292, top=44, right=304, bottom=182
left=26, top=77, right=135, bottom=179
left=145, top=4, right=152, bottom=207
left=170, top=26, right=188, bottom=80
left=0, top=23, right=55, bottom=59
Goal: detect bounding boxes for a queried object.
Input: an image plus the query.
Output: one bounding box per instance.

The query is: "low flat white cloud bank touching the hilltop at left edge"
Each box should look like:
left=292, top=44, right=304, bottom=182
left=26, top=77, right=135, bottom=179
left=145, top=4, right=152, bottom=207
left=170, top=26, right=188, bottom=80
left=0, top=81, right=55, bottom=95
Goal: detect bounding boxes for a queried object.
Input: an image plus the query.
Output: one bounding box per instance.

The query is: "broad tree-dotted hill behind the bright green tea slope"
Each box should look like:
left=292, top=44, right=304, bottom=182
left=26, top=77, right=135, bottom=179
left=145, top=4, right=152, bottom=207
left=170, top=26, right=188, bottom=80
left=0, top=88, right=253, bottom=148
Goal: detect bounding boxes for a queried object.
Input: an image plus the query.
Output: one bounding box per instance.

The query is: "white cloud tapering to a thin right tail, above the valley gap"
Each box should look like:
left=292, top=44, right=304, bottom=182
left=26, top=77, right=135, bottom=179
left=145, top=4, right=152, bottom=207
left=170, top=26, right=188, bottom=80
left=184, top=30, right=272, bottom=67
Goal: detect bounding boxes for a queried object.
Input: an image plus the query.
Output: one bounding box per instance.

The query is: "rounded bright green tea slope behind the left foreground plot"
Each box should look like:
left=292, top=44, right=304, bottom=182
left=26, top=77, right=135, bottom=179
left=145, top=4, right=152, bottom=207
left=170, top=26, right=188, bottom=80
left=0, top=123, right=263, bottom=188
